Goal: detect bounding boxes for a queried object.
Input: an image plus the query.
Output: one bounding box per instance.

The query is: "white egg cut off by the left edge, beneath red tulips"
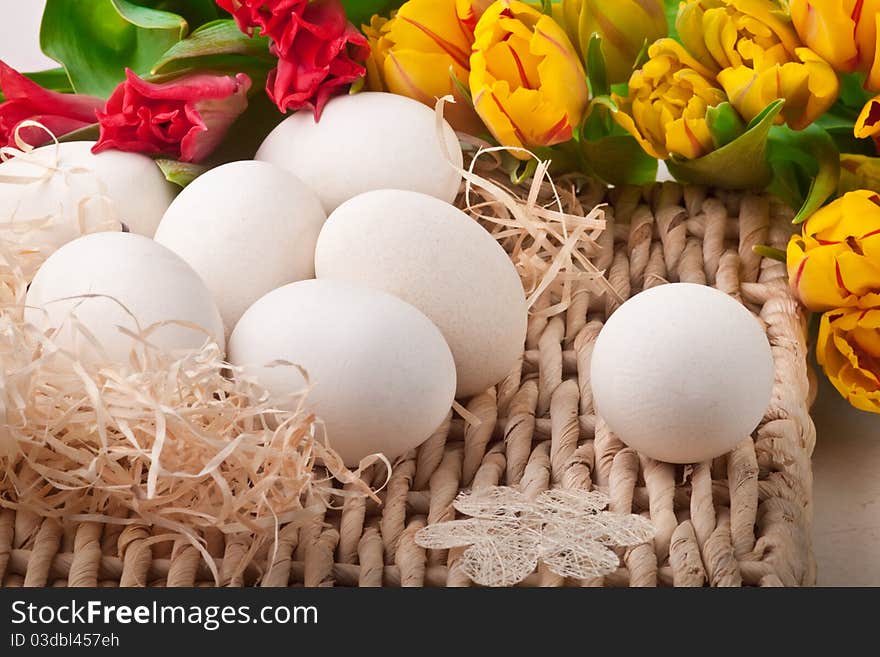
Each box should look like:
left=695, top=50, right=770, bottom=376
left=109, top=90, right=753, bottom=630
left=0, top=141, right=174, bottom=253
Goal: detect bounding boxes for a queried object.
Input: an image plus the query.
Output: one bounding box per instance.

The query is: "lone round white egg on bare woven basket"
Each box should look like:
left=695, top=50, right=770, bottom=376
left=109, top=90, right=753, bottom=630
left=590, top=283, right=774, bottom=463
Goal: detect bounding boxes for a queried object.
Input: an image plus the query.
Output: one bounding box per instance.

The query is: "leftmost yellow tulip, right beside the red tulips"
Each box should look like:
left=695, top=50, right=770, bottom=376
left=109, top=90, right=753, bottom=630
left=364, top=0, right=483, bottom=134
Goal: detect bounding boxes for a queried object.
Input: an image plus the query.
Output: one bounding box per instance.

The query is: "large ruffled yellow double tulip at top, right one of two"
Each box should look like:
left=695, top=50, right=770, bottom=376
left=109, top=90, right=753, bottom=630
left=676, top=0, right=840, bottom=130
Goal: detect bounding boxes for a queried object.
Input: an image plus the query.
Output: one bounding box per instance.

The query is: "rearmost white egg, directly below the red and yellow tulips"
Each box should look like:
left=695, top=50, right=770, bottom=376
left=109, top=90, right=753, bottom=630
left=256, top=92, right=462, bottom=213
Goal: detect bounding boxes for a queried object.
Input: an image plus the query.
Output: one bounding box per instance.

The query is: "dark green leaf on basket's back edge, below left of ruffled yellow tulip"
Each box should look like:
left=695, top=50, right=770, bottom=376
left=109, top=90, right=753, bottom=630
left=581, top=135, right=657, bottom=185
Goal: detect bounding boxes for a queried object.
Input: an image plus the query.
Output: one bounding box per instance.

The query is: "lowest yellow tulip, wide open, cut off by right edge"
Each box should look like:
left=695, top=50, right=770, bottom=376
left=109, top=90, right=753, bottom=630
left=816, top=309, right=880, bottom=413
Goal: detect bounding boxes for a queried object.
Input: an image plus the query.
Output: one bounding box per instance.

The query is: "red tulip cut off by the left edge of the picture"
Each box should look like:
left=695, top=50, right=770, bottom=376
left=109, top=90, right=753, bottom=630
left=0, top=60, right=104, bottom=146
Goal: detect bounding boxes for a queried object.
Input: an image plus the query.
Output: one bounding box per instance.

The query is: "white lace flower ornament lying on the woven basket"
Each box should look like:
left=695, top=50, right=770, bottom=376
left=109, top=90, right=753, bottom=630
left=416, top=486, right=654, bottom=586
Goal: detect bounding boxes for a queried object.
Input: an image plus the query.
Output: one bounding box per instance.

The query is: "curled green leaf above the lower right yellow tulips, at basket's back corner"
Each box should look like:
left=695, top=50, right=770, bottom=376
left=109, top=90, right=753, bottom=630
left=768, top=125, right=840, bottom=224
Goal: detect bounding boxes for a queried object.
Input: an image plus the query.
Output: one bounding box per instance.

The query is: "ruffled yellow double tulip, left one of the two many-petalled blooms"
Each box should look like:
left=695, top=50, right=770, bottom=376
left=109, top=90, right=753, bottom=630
left=614, top=38, right=727, bottom=160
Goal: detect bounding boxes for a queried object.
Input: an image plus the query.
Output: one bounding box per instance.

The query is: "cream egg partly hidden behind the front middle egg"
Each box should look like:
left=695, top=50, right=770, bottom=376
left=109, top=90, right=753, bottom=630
left=315, top=190, right=528, bottom=397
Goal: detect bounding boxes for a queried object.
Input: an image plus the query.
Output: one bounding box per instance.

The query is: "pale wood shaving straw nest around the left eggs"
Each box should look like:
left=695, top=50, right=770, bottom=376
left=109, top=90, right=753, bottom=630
left=0, top=129, right=374, bottom=576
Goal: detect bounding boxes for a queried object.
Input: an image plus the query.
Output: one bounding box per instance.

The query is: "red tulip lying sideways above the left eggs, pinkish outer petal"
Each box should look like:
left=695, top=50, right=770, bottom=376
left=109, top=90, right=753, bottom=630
left=92, top=70, right=251, bottom=162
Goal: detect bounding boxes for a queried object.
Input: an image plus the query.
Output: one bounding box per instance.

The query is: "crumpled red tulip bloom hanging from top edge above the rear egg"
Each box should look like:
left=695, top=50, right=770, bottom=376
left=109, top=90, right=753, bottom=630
left=217, top=0, right=370, bottom=119
